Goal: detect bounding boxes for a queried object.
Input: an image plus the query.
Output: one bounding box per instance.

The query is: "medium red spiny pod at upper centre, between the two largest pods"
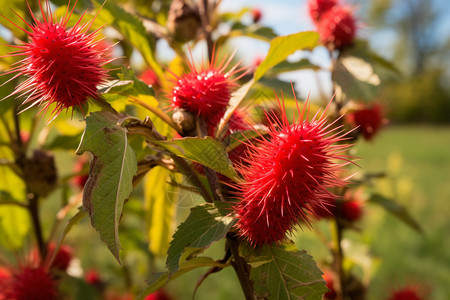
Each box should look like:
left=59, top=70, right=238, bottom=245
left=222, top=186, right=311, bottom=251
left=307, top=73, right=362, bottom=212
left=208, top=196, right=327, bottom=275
left=170, top=50, right=244, bottom=124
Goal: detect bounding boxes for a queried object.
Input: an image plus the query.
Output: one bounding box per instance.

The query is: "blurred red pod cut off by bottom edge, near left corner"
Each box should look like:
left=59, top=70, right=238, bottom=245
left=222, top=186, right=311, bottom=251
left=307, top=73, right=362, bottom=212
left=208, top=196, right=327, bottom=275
left=6, top=267, right=58, bottom=300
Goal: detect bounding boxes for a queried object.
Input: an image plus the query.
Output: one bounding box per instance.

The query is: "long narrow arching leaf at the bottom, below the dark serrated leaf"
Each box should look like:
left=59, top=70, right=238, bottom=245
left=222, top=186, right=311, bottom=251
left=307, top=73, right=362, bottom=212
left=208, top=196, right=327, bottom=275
left=136, top=257, right=228, bottom=300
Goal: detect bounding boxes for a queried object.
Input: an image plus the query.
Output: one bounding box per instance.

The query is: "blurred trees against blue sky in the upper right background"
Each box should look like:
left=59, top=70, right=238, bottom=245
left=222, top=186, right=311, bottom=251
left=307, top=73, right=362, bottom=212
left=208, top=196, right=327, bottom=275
left=364, top=0, right=450, bottom=123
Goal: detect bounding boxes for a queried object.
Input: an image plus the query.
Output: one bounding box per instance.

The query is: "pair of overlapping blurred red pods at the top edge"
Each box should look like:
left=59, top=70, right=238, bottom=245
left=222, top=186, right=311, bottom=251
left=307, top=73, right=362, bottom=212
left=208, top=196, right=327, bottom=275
left=308, top=0, right=356, bottom=49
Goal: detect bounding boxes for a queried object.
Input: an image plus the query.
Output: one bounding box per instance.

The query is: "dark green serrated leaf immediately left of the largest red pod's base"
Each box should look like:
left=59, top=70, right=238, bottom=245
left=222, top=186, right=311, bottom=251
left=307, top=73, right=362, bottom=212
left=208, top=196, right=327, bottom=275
left=166, top=203, right=236, bottom=274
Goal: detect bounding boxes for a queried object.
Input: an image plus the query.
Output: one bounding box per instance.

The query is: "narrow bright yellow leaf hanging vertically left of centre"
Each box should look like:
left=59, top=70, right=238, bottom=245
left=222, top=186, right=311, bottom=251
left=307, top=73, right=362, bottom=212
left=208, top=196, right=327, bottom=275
left=144, top=167, right=176, bottom=256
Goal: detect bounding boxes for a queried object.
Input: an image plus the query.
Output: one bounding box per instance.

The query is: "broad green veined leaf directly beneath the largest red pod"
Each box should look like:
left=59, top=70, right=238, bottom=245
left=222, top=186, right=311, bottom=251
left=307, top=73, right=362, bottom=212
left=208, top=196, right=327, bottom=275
left=250, top=246, right=328, bottom=300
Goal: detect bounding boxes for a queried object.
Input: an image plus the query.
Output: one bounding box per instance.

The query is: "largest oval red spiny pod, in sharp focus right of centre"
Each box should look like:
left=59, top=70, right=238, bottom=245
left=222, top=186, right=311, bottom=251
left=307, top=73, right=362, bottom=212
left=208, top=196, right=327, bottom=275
left=236, top=96, right=356, bottom=246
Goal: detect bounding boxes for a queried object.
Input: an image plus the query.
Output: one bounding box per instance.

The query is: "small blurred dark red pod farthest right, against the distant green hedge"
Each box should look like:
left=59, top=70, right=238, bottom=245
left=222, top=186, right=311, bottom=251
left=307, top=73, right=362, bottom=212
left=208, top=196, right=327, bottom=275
left=347, top=104, right=384, bottom=141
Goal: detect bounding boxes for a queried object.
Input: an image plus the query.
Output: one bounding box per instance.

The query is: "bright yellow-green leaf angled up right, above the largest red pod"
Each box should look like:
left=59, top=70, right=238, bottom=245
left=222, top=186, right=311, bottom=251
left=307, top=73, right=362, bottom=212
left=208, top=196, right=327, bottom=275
left=254, top=31, right=319, bottom=81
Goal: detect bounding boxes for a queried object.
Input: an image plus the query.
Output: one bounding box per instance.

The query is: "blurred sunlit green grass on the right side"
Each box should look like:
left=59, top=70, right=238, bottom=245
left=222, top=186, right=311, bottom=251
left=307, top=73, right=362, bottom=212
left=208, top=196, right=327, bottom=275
left=356, top=126, right=450, bottom=300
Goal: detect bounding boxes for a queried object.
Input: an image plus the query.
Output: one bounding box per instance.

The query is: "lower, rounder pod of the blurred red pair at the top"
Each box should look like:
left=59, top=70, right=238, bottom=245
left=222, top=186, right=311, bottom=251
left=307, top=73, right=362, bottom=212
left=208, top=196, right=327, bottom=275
left=317, top=6, right=356, bottom=49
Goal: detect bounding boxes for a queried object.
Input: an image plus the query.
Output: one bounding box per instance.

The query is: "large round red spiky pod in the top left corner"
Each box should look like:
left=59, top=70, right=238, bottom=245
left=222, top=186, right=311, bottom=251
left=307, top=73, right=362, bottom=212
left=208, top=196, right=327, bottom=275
left=1, top=0, right=111, bottom=117
